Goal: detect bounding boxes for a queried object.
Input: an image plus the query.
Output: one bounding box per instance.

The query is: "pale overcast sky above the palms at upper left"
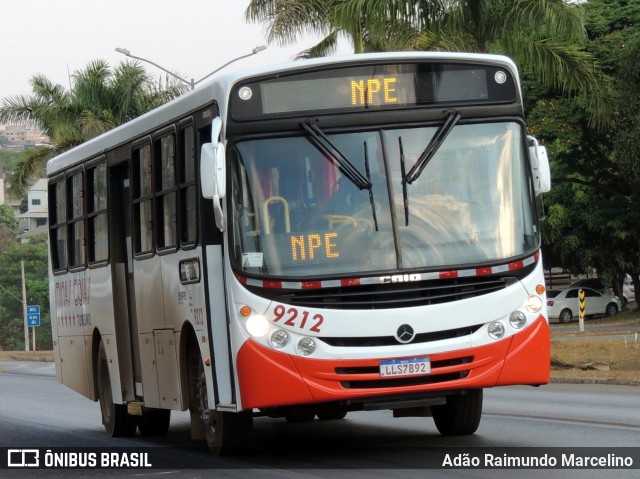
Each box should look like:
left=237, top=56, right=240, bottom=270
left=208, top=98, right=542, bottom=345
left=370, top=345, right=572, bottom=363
left=0, top=0, right=349, bottom=99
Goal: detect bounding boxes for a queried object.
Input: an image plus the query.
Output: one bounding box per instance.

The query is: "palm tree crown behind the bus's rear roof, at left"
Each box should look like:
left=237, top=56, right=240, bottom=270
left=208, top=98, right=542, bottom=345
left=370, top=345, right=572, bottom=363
left=0, top=60, right=187, bottom=196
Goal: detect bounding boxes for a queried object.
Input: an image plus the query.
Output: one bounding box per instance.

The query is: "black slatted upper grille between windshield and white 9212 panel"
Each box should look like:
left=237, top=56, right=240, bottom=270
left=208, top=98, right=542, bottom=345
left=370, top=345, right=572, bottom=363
left=274, top=276, right=510, bottom=309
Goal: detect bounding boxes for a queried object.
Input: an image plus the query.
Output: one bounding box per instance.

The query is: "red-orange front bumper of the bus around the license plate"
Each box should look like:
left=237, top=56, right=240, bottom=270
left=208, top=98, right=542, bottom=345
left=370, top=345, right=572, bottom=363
left=237, top=316, right=551, bottom=409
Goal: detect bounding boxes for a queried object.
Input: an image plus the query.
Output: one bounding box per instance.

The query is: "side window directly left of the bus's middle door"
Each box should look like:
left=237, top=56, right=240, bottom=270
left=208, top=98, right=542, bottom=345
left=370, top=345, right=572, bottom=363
left=87, top=162, right=109, bottom=264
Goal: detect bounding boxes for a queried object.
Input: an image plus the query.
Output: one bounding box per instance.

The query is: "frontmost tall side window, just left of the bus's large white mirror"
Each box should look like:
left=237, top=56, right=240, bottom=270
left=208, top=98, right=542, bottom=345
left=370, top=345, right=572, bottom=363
left=179, top=125, right=198, bottom=246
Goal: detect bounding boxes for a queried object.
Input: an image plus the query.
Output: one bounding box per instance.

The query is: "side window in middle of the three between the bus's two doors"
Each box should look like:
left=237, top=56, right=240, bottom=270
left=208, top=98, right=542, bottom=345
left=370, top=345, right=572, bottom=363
left=154, top=133, right=178, bottom=249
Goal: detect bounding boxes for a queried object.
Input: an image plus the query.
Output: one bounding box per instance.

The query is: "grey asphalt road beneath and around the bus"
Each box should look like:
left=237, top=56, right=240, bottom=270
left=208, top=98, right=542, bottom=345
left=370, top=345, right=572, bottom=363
left=0, top=362, right=640, bottom=479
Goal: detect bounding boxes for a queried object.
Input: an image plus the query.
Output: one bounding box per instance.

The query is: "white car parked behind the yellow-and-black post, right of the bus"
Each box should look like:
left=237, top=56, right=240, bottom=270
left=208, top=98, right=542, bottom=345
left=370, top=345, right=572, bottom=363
left=547, top=287, right=622, bottom=323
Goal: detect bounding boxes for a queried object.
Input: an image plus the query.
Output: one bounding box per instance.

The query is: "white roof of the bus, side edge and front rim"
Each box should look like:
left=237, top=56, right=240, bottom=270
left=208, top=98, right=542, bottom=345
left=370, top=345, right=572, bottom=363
left=47, top=52, right=520, bottom=176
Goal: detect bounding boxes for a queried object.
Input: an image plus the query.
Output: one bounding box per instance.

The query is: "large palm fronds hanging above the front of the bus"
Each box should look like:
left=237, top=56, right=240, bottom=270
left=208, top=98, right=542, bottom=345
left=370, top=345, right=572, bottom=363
left=245, top=0, right=610, bottom=126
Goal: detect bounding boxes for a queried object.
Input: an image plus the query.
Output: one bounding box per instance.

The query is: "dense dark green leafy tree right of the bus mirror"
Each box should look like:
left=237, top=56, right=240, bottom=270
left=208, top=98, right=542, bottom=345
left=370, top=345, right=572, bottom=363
left=528, top=0, right=640, bottom=304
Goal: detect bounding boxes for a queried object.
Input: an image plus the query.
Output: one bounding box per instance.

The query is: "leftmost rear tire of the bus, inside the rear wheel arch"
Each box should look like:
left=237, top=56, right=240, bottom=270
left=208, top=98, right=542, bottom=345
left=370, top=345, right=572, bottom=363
left=96, top=340, right=137, bottom=437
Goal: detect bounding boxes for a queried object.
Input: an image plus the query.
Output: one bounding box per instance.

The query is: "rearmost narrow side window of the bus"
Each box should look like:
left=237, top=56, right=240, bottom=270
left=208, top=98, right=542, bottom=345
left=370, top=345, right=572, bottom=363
left=49, top=179, right=69, bottom=271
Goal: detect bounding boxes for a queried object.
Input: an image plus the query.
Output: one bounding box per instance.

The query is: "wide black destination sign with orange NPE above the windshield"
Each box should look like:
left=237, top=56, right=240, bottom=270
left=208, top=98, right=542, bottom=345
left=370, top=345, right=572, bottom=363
left=231, top=63, right=516, bottom=120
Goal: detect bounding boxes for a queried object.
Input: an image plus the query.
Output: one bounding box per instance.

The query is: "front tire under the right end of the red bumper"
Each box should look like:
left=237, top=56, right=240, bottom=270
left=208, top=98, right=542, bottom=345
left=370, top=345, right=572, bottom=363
left=431, top=389, right=482, bottom=436
